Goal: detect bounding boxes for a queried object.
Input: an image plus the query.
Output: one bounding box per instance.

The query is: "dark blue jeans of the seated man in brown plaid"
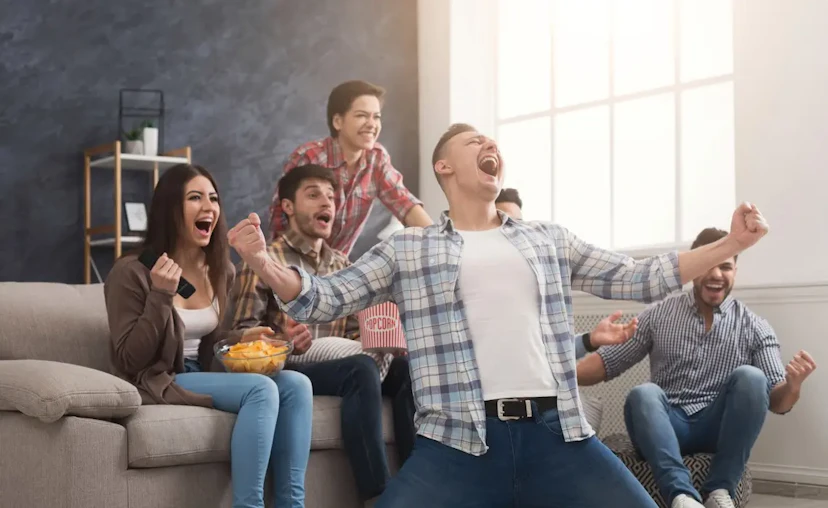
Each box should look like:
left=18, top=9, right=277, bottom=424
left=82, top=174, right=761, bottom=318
left=290, top=355, right=415, bottom=500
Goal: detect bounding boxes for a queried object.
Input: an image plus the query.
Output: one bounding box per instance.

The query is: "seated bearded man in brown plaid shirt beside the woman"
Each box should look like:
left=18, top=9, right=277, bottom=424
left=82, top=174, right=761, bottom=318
left=231, top=164, right=414, bottom=501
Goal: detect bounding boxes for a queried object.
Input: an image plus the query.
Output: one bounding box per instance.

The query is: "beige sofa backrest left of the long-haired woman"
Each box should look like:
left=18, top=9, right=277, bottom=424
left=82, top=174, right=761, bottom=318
left=0, top=282, right=109, bottom=372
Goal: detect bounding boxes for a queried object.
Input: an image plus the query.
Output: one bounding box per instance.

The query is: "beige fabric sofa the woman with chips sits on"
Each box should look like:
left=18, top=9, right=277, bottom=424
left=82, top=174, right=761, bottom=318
left=0, top=282, right=396, bottom=508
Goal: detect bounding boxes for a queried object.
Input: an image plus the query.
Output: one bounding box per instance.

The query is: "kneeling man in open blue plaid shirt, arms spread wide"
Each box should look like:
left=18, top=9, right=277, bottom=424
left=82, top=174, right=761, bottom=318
left=228, top=124, right=767, bottom=508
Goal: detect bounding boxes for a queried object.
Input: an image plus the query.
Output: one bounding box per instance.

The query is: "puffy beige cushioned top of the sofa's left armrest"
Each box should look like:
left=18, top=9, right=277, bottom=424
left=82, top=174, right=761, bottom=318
left=0, top=360, right=141, bottom=423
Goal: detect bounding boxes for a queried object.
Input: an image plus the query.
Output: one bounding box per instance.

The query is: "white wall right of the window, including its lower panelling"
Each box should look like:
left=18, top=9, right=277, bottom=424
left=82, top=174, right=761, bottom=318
left=734, top=0, right=828, bottom=485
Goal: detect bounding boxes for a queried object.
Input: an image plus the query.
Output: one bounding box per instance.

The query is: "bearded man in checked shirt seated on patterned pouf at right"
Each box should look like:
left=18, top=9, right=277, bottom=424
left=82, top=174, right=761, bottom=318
left=578, top=228, right=816, bottom=508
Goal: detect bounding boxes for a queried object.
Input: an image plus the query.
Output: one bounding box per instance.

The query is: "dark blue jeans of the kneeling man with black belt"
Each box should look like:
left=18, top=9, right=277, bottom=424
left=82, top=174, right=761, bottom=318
left=376, top=407, right=656, bottom=508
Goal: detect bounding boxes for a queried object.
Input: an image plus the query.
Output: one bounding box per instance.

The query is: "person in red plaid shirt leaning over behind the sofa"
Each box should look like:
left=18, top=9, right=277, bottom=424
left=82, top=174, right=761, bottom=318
left=270, top=81, right=432, bottom=256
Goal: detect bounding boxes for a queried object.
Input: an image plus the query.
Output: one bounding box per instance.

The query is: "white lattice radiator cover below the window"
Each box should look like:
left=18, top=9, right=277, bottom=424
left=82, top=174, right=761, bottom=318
left=575, top=312, right=650, bottom=439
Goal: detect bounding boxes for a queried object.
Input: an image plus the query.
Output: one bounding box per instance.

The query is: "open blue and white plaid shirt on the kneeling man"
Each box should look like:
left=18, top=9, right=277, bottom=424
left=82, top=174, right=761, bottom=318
left=280, top=213, right=681, bottom=455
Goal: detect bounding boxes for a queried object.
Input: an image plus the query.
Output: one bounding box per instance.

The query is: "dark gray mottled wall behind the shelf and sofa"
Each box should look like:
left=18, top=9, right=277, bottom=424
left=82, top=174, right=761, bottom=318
left=0, top=0, right=418, bottom=283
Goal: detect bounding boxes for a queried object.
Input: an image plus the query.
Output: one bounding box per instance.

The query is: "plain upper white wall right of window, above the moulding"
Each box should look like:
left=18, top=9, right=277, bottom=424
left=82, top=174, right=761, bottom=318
left=734, top=0, right=828, bottom=285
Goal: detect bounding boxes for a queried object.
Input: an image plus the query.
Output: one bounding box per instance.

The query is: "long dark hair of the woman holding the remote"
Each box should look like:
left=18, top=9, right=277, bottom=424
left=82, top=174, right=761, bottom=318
left=144, top=164, right=232, bottom=323
